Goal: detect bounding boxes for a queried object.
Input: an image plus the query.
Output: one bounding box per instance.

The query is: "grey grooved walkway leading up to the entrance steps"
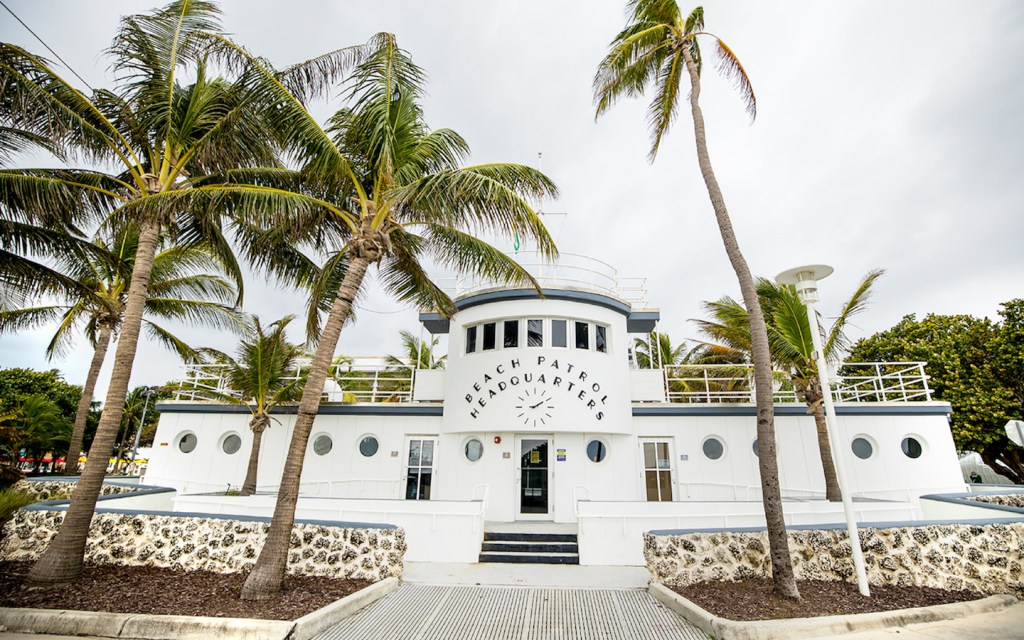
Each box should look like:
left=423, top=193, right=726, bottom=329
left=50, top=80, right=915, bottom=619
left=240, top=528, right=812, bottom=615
left=315, top=584, right=708, bottom=640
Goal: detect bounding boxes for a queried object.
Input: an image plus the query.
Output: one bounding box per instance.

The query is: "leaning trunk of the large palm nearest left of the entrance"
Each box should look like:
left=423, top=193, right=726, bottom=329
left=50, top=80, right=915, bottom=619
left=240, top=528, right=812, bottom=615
left=242, top=255, right=370, bottom=600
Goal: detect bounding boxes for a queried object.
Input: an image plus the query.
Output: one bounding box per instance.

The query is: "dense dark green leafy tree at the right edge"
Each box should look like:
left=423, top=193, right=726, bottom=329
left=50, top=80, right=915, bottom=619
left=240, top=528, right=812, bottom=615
left=850, top=299, right=1024, bottom=483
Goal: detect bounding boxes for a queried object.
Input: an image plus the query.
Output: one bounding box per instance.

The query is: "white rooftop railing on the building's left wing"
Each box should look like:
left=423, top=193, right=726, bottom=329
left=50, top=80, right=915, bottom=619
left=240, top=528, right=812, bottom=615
left=174, top=357, right=416, bottom=402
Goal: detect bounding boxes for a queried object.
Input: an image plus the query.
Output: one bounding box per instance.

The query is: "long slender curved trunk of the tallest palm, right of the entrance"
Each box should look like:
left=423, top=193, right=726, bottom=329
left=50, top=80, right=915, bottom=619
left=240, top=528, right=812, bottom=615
left=682, top=42, right=800, bottom=599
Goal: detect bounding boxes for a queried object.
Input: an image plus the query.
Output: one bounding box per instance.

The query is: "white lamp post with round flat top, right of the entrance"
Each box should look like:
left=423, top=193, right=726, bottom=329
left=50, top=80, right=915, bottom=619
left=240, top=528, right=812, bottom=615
left=775, top=264, right=871, bottom=596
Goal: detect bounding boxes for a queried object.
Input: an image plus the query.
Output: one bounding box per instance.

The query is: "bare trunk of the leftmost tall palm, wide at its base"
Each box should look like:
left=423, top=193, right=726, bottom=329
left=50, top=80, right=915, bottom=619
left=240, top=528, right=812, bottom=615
left=28, top=220, right=160, bottom=585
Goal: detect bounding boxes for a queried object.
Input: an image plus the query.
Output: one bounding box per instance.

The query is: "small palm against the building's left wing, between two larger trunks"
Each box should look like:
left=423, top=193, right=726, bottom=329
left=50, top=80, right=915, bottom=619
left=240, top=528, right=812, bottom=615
left=193, top=315, right=305, bottom=496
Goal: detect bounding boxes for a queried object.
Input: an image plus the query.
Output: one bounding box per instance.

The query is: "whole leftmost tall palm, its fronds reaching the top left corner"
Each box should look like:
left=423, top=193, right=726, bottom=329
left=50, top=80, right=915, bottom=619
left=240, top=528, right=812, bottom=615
left=0, top=0, right=361, bottom=585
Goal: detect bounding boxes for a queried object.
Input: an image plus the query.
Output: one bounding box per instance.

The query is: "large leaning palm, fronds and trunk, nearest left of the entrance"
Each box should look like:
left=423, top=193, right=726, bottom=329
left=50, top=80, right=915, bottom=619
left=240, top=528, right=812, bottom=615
left=236, top=34, right=556, bottom=599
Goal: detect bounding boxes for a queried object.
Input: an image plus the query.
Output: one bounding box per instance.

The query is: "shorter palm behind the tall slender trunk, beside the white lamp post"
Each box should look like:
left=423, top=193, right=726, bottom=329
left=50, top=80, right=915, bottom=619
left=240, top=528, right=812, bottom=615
left=696, top=269, right=885, bottom=502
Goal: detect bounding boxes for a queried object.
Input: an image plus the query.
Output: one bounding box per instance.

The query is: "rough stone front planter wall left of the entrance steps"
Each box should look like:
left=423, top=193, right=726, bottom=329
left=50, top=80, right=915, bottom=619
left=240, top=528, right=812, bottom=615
left=0, top=510, right=406, bottom=581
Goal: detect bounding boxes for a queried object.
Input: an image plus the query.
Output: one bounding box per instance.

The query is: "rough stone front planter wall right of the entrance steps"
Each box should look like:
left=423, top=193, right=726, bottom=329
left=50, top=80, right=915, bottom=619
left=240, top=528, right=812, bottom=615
left=644, top=522, right=1024, bottom=596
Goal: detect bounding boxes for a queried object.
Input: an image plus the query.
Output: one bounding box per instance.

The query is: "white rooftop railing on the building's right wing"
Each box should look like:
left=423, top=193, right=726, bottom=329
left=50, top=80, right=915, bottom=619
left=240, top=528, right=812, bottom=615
left=663, top=362, right=932, bottom=404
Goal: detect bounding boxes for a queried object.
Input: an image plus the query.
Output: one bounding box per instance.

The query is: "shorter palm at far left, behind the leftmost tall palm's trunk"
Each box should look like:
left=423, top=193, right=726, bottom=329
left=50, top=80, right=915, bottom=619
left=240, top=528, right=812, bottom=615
left=0, top=224, right=241, bottom=469
